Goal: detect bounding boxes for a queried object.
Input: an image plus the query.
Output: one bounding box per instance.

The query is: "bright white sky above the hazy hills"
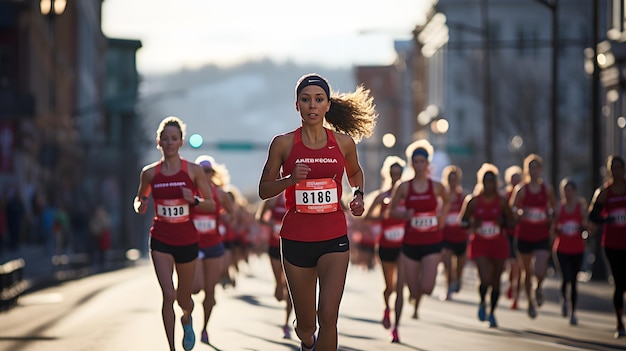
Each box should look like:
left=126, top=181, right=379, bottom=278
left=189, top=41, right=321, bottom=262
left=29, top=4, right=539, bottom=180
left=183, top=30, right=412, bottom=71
left=102, top=0, right=432, bottom=74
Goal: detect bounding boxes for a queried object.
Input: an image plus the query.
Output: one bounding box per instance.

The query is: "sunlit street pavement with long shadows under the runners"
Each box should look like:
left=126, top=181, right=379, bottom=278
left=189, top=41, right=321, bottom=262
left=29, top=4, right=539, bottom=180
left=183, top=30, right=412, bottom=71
left=0, top=248, right=626, bottom=351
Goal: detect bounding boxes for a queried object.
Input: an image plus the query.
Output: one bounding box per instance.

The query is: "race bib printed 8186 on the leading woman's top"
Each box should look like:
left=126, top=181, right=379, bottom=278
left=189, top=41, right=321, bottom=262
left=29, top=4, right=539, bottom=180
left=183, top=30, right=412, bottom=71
left=296, top=178, right=339, bottom=213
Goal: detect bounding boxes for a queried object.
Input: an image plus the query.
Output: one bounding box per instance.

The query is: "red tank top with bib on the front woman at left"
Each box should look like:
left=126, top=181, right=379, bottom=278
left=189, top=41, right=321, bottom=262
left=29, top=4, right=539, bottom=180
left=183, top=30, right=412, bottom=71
left=150, top=160, right=199, bottom=246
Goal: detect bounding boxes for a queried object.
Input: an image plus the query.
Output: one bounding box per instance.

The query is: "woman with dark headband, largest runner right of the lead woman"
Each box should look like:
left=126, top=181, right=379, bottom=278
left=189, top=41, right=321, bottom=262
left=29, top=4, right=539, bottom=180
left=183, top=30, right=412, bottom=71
left=389, top=139, right=450, bottom=342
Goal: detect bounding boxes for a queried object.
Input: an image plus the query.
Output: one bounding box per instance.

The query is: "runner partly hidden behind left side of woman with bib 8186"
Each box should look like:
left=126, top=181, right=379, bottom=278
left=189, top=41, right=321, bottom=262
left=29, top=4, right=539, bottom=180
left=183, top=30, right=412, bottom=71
left=257, top=192, right=293, bottom=339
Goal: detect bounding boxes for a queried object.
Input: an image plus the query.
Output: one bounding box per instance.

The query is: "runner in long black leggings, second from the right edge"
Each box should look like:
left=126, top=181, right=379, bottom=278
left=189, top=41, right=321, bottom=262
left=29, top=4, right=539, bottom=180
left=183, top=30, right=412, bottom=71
left=552, top=178, right=589, bottom=325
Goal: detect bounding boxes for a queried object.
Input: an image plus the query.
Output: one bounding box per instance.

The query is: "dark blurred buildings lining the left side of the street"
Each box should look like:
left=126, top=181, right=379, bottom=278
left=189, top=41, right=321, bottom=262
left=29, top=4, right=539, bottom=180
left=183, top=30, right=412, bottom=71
left=0, top=0, right=141, bottom=251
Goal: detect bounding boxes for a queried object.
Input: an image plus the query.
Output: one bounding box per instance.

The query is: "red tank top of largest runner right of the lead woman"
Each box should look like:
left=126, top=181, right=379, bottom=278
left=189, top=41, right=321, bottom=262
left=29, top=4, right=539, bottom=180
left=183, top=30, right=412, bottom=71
left=403, top=179, right=443, bottom=245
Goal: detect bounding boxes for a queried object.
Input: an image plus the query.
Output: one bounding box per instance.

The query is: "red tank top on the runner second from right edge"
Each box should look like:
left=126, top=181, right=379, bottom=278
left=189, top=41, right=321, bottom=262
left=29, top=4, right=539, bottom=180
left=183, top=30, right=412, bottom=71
left=552, top=203, right=585, bottom=254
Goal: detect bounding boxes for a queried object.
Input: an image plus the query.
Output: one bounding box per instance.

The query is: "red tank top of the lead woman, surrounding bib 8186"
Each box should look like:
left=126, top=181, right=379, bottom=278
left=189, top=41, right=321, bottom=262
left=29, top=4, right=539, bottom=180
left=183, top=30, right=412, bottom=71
left=280, top=127, right=348, bottom=242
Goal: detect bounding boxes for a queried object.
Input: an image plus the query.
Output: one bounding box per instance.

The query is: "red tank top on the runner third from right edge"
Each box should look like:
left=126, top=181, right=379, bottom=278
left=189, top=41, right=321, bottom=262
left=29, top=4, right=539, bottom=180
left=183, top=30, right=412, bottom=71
left=515, top=184, right=550, bottom=242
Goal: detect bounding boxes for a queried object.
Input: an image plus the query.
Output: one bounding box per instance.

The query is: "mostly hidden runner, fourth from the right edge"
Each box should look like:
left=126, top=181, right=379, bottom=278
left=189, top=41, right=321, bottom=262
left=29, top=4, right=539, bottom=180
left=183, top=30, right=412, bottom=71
left=504, top=166, right=522, bottom=310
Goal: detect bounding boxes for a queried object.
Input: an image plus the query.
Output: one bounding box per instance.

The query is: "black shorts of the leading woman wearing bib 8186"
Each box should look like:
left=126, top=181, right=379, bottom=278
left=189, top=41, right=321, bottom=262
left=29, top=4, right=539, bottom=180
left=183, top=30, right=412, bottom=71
left=280, top=235, right=350, bottom=268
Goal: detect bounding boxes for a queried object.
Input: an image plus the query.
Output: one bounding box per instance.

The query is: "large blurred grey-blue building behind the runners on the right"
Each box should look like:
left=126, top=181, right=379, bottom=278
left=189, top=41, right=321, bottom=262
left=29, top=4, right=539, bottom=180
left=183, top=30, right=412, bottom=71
left=415, top=0, right=592, bottom=191
